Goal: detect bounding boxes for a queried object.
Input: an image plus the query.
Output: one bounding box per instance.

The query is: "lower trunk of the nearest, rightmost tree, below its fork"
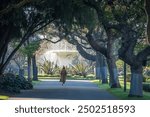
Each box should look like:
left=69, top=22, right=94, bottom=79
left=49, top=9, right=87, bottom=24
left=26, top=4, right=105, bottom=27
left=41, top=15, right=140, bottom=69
left=129, top=66, right=143, bottom=97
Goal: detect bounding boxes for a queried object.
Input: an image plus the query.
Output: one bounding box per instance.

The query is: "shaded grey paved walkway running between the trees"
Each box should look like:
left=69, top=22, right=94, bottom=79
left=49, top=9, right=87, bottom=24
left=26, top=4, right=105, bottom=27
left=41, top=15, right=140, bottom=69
left=10, top=80, right=117, bottom=100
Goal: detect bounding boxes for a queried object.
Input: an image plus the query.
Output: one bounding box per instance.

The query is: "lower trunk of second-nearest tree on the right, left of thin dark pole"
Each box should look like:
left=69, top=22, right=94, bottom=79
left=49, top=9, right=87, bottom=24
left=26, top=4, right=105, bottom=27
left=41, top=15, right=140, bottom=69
left=107, top=58, right=120, bottom=88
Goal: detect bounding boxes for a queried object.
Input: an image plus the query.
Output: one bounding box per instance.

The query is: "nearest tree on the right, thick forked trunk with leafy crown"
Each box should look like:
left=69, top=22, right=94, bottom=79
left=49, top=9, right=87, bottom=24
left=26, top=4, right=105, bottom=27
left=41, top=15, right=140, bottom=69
left=99, top=0, right=150, bottom=97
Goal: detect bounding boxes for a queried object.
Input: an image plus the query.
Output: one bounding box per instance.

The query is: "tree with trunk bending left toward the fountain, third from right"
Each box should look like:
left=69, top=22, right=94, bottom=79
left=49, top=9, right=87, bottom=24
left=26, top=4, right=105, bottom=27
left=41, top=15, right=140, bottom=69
left=68, top=31, right=108, bottom=84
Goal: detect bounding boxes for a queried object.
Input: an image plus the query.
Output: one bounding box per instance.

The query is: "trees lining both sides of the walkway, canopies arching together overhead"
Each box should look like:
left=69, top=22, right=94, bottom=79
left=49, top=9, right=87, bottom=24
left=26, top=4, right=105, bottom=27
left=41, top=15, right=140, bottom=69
left=0, top=0, right=150, bottom=97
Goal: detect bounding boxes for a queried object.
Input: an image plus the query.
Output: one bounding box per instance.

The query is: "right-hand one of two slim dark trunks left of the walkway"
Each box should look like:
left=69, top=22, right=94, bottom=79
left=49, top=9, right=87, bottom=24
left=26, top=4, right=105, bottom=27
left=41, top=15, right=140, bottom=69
left=32, top=55, right=38, bottom=81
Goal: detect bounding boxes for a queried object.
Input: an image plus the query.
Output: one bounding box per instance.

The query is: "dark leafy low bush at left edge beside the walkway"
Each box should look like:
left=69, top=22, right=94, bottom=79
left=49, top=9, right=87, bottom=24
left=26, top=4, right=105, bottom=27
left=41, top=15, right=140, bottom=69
left=0, top=73, right=33, bottom=93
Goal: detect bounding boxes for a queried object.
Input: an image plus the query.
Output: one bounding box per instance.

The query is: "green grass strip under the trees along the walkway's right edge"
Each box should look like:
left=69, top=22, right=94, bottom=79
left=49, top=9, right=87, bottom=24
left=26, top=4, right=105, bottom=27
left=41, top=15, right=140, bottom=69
left=92, top=80, right=150, bottom=100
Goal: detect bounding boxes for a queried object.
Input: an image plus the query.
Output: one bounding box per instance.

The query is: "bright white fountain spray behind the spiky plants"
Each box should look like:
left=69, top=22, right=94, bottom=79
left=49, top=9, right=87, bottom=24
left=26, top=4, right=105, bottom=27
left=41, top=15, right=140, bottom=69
left=37, top=40, right=78, bottom=67
